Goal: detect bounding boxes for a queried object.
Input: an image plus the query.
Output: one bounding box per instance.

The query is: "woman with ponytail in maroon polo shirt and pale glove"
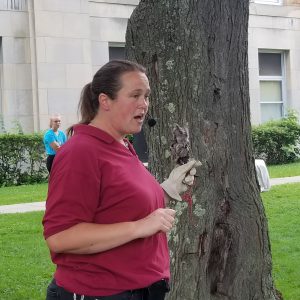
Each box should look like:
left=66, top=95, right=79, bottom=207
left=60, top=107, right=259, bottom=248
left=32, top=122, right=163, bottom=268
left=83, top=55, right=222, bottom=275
left=43, top=61, right=195, bottom=300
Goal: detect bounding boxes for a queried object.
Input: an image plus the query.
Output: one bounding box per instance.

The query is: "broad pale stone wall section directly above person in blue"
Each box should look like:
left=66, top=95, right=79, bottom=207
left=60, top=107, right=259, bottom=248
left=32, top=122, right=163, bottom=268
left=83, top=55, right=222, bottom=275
left=33, top=0, right=92, bottom=130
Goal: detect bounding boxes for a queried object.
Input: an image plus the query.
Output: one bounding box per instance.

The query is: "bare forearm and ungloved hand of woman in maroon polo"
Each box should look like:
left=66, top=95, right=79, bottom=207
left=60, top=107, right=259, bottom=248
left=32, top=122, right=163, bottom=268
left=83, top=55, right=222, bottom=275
left=47, top=208, right=175, bottom=254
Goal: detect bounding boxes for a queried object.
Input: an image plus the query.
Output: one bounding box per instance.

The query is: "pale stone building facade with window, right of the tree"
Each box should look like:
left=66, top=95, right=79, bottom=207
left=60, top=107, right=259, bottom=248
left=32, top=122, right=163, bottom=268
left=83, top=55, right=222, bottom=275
left=248, top=0, right=300, bottom=124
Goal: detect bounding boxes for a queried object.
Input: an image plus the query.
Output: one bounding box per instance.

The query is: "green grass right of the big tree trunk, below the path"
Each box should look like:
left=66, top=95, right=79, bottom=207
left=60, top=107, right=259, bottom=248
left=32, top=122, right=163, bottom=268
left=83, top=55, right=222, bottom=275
left=262, top=183, right=300, bottom=300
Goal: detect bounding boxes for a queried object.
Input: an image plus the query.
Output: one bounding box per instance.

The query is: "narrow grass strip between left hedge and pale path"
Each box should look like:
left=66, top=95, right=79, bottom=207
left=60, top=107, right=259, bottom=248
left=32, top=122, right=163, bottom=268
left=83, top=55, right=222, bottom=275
left=0, top=183, right=48, bottom=205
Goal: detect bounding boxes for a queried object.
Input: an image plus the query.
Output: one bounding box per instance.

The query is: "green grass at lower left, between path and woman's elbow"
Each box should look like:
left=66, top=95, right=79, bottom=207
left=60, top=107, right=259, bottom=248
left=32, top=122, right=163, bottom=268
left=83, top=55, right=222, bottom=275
left=0, top=212, right=54, bottom=300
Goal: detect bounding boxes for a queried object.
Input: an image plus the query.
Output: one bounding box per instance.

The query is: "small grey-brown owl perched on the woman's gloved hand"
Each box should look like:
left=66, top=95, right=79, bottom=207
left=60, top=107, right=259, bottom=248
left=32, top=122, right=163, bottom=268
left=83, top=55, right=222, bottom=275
left=170, top=124, right=190, bottom=165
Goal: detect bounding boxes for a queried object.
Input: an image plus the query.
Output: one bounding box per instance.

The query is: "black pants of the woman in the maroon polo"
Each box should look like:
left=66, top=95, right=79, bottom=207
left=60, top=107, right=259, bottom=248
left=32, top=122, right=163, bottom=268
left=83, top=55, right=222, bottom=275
left=46, top=279, right=169, bottom=300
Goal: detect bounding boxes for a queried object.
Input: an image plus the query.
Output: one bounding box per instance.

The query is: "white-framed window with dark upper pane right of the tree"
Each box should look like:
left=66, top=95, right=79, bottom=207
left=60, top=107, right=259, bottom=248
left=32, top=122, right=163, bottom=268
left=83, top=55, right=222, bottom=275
left=258, top=52, right=285, bottom=122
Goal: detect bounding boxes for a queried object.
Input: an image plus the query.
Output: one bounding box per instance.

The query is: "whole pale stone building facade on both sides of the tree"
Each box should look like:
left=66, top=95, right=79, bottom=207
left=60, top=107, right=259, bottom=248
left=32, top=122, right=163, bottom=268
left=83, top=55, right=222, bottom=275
left=0, top=0, right=300, bottom=132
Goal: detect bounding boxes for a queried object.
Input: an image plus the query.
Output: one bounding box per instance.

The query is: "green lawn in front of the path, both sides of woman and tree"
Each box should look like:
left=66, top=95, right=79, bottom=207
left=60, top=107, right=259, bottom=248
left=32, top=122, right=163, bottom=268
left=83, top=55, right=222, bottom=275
left=0, top=183, right=300, bottom=300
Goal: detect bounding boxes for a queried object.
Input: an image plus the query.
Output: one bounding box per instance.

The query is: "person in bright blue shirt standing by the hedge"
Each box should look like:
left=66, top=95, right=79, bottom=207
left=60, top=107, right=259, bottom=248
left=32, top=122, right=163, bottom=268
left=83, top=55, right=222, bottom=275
left=43, top=115, right=67, bottom=173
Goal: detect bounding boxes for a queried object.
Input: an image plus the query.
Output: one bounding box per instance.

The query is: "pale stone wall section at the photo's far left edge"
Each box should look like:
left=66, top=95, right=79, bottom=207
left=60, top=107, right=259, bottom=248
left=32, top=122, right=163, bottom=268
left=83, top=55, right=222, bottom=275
left=0, top=5, right=33, bottom=131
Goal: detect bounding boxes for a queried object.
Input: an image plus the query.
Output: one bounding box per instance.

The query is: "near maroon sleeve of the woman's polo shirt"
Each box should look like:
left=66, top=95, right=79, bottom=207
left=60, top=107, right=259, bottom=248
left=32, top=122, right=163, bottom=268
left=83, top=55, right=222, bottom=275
left=43, top=147, right=101, bottom=238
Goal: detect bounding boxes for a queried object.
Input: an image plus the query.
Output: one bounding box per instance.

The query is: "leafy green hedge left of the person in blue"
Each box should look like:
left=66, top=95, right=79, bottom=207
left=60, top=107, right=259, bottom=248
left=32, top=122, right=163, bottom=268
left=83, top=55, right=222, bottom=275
left=0, top=133, right=48, bottom=187
